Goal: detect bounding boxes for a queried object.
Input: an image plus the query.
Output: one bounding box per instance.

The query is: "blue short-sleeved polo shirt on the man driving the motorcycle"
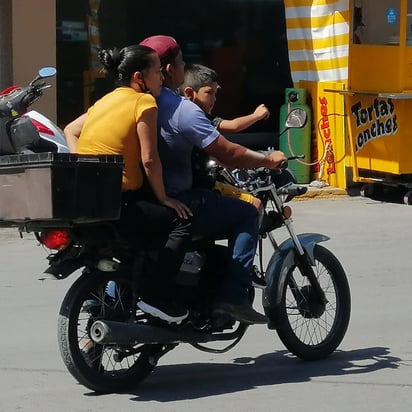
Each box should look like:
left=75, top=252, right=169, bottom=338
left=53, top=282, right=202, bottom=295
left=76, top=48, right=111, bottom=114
left=157, top=87, right=220, bottom=196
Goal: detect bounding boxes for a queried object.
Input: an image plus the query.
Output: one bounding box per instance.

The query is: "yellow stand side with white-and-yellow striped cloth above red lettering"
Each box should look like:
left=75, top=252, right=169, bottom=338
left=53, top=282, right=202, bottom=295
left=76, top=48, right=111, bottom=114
left=285, top=0, right=350, bottom=188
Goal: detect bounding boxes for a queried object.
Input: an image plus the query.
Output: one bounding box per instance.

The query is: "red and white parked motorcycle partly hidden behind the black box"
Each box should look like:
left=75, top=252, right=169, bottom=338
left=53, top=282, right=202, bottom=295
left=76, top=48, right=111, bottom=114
left=0, top=67, right=69, bottom=155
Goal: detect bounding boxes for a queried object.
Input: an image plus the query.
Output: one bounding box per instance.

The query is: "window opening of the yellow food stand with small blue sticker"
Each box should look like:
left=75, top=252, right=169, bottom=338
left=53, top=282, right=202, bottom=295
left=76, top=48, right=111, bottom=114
left=352, top=0, right=401, bottom=45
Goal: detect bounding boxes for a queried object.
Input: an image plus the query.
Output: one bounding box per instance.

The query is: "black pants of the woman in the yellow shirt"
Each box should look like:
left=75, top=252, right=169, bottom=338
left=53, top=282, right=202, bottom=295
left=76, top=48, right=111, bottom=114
left=119, top=191, right=192, bottom=300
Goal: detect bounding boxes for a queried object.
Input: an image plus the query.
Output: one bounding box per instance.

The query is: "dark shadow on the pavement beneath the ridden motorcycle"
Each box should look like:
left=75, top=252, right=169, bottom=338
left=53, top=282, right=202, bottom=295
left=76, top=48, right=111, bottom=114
left=93, top=347, right=401, bottom=402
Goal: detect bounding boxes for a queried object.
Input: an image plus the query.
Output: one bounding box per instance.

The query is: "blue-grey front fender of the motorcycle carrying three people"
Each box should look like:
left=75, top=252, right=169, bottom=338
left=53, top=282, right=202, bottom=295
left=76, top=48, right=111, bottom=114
left=262, top=233, right=330, bottom=329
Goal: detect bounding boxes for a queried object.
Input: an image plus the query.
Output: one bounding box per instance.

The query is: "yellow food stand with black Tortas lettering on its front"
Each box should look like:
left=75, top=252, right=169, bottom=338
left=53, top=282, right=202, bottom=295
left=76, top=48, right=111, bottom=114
left=345, top=0, right=412, bottom=181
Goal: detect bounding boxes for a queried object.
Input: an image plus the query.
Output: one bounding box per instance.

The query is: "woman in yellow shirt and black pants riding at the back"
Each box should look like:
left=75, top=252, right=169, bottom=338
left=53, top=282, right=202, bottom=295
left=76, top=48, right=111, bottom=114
left=64, top=46, right=191, bottom=323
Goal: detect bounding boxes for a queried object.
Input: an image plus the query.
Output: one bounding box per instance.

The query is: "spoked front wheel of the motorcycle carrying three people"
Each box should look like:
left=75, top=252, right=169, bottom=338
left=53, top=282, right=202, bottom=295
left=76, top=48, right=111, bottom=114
left=276, top=245, right=351, bottom=360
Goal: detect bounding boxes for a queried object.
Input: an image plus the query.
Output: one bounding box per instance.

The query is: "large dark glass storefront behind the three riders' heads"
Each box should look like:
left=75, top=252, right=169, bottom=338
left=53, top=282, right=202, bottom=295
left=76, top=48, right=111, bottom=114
left=57, top=0, right=292, bottom=132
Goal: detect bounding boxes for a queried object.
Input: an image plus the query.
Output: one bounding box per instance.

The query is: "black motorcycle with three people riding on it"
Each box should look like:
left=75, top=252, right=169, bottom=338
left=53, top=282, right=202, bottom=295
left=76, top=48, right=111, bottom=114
left=11, top=109, right=351, bottom=392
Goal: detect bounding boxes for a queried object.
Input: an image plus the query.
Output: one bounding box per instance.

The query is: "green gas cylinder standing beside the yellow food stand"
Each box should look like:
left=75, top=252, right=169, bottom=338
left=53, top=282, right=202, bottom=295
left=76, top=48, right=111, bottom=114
left=279, top=88, right=312, bottom=183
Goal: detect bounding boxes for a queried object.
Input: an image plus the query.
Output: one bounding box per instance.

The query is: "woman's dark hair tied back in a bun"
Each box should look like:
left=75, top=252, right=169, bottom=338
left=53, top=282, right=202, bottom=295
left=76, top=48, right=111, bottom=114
left=99, top=45, right=156, bottom=86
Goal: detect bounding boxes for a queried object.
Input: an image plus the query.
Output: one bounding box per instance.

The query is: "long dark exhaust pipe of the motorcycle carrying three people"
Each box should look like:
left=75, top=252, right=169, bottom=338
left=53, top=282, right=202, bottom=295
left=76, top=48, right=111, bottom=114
left=90, top=320, right=233, bottom=345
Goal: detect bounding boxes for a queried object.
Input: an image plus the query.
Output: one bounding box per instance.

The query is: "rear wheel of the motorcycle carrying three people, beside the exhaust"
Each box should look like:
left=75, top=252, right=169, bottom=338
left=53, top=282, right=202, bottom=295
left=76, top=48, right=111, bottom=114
left=58, top=270, right=162, bottom=392
